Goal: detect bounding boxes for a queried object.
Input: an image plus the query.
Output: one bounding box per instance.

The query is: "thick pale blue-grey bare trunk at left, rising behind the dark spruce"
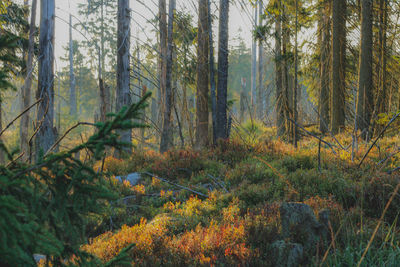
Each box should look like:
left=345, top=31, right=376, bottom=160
left=36, top=0, right=56, bottom=158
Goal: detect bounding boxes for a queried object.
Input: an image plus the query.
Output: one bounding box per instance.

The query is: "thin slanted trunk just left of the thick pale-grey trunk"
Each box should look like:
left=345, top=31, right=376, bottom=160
left=20, top=0, right=37, bottom=160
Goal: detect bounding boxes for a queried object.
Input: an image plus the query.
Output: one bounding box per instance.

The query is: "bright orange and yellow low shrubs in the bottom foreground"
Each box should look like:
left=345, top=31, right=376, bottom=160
left=83, top=198, right=254, bottom=266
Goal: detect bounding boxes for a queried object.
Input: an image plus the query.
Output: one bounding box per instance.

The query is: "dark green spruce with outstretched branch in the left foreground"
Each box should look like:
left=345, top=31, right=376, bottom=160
left=0, top=94, right=150, bottom=266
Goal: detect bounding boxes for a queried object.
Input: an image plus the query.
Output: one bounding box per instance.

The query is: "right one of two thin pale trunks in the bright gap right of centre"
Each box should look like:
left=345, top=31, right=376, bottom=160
left=257, top=0, right=264, bottom=120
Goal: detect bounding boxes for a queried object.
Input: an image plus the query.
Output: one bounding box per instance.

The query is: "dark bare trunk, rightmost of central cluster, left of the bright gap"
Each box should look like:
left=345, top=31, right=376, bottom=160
left=216, top=0, right=229, bottom=142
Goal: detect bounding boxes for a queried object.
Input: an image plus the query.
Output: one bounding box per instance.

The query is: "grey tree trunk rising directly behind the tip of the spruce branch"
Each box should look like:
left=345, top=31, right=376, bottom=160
left=116, top=0, right=132, bottom=156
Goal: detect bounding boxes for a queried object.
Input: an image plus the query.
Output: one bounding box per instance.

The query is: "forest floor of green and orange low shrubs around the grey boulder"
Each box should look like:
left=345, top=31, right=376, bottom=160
left=81, top=124, right=400, bottom=266
